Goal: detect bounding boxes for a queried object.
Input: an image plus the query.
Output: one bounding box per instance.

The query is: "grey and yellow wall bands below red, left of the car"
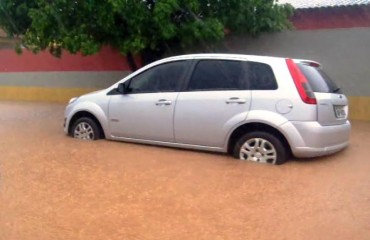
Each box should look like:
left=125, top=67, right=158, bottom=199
left=0, top=71, right=129, bottom=103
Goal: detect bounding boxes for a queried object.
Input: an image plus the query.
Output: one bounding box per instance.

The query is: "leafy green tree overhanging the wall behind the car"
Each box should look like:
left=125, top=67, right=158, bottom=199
left=0, top=0, right=293, bottom=70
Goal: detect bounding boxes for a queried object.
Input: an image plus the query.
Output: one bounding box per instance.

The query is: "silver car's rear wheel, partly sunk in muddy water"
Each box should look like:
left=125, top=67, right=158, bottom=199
left=233, top=131, right=288, bottom=165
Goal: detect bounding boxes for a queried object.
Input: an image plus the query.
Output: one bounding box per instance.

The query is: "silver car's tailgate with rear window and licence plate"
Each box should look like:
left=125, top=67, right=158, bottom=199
left=298, top=62, right=348, bottom=125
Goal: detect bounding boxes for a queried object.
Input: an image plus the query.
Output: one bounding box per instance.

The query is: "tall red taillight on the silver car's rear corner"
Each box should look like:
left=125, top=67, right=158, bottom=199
left=286, top=58, right=317, bottom=104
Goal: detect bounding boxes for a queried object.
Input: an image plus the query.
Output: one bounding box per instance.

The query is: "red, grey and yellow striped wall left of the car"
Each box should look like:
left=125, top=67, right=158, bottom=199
left=0, top=48, right=130, bottom=102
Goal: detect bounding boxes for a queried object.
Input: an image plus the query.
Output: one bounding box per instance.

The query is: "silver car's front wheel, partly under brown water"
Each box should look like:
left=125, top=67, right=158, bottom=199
left=71, top=117, right=101, bottom=140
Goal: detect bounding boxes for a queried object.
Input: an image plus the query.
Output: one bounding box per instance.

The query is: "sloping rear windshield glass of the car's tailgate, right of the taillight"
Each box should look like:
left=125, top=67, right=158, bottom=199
left=298, top=63, right=342, bottom=93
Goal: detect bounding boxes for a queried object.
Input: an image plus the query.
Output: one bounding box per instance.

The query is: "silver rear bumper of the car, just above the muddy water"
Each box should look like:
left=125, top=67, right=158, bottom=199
left=289, top=121, right=351, bottom=157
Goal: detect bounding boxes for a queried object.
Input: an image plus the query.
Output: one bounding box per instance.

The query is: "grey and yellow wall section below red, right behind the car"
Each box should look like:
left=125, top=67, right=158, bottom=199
left=215, top=28, right=370, bottom=120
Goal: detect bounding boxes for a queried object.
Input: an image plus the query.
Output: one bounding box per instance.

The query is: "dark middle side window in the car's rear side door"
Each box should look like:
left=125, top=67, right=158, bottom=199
left=188, top=60, right=245, bottom=91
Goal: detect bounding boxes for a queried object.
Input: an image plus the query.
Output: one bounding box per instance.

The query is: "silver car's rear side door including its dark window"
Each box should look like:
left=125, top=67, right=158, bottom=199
left=175, top=59, right=251, bottom=148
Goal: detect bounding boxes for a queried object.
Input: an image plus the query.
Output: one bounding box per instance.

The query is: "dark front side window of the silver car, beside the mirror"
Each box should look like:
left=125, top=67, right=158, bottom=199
left=128, top=61, right=187, bottom=93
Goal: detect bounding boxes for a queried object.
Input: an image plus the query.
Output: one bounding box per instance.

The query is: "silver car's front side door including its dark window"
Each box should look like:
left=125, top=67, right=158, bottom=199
left=109, top=61, right=187, bottom=142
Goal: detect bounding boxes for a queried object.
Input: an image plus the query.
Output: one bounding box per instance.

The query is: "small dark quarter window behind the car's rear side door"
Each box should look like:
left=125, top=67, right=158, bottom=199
left=246, top=62, right=278, bottom=90
